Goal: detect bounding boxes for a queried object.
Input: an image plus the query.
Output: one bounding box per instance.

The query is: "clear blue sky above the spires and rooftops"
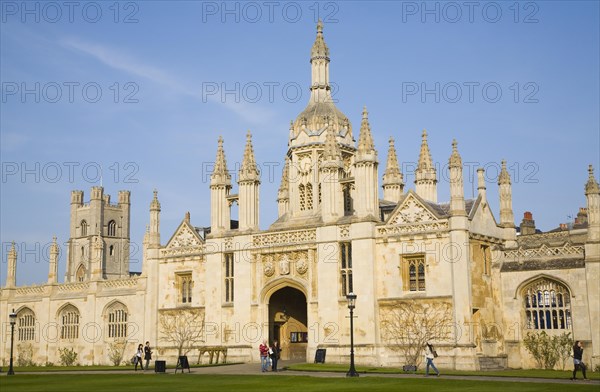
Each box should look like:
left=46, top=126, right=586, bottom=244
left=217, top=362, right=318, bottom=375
left=0, top=1, right=600, bottom=285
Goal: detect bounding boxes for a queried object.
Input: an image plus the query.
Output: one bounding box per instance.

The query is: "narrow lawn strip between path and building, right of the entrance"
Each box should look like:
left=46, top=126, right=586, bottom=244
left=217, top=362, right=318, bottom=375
left=288, top=363, right=600, bottom=380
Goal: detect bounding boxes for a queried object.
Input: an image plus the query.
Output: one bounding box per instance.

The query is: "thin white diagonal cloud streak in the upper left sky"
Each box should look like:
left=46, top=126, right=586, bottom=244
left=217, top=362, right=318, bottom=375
left=60, top=38, right=274, bottom=124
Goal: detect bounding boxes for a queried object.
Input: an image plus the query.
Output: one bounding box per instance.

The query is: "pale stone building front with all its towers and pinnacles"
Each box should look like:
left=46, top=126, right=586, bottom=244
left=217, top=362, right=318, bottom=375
left=0, top=23, right=600, bottom=369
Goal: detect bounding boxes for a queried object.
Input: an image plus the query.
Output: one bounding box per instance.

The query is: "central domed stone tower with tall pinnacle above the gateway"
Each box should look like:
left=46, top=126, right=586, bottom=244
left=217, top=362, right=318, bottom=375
left=276, top=21, right=356, bottom=225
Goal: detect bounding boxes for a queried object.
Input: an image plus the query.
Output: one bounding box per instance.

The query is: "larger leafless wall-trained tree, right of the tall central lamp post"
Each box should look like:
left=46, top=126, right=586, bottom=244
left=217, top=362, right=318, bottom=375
left=381, top=300, right=454, bottom=366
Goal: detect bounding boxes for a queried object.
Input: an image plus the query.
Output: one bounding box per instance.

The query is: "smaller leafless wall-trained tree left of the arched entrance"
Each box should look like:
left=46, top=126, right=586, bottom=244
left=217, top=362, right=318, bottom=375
left=160, top=309, right=204, bottom=356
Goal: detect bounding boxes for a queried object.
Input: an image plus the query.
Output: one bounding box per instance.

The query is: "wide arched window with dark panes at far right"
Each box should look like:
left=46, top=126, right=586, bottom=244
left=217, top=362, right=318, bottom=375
left=523, top=278, right=572, bottom=330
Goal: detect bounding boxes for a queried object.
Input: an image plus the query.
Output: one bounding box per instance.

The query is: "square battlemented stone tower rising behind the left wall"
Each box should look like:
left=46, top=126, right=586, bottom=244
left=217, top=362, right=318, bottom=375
left=65, top=186, right=131, bottom=282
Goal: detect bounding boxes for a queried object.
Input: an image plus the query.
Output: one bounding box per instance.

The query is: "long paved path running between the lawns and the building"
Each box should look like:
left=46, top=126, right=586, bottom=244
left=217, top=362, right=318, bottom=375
left=1, top=361, right=600, bottom=386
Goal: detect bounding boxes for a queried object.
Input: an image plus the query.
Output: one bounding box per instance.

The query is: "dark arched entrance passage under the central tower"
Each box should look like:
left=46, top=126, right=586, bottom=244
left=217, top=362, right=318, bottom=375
left=269, top=287, right=308, bottom=361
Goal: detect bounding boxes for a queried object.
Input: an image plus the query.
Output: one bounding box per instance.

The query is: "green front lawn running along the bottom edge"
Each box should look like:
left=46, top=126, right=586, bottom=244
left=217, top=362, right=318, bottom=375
left=0, top=373, right=598, bottom=392
